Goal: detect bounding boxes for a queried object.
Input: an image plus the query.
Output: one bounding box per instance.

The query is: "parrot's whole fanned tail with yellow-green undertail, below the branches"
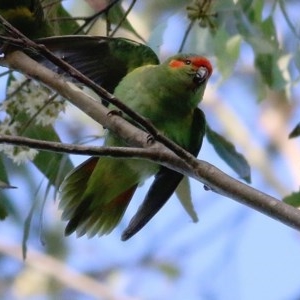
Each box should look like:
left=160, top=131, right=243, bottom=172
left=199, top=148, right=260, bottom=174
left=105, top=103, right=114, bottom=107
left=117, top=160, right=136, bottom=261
left=59, top=157, right=146, bottom=237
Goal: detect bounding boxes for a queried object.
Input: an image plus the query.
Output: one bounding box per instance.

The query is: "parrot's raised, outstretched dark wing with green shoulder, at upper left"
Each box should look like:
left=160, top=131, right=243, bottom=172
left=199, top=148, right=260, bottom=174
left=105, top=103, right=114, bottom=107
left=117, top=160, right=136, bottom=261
left=27, top=35, right=159, bottom=93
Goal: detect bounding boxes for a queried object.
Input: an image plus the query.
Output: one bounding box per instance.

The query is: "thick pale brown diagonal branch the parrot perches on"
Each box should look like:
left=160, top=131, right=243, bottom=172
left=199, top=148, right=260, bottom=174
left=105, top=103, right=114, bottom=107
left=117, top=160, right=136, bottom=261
left=2, top=51, right=300, bottom=230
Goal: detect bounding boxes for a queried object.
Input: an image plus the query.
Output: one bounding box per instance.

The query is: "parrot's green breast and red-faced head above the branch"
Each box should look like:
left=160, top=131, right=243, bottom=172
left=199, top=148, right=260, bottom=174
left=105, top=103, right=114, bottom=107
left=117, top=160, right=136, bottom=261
left=114, top=58, right=211, bottom=143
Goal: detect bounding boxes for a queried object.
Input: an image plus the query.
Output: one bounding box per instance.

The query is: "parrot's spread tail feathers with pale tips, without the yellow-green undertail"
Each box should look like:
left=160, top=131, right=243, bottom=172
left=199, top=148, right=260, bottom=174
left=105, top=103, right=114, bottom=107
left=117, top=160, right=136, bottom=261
left=59, top=157, right=138, bottom=237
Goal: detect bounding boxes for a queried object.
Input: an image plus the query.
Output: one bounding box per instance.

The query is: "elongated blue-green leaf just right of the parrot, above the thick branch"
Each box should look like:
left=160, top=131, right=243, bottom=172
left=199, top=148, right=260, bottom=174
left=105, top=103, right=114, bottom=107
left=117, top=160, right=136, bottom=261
left=206, top=125, right=251, bottom=183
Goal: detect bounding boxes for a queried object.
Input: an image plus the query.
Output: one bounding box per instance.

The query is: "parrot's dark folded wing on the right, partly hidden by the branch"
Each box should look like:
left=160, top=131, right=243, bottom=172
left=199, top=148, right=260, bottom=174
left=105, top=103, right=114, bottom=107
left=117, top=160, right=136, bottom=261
left=122, top=108, right=206, bottom=241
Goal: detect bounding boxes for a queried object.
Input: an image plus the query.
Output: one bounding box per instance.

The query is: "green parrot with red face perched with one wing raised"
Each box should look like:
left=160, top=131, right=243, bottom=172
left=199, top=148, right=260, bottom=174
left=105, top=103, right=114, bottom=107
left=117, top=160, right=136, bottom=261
left=29, top=36, right=212, bottom=240
